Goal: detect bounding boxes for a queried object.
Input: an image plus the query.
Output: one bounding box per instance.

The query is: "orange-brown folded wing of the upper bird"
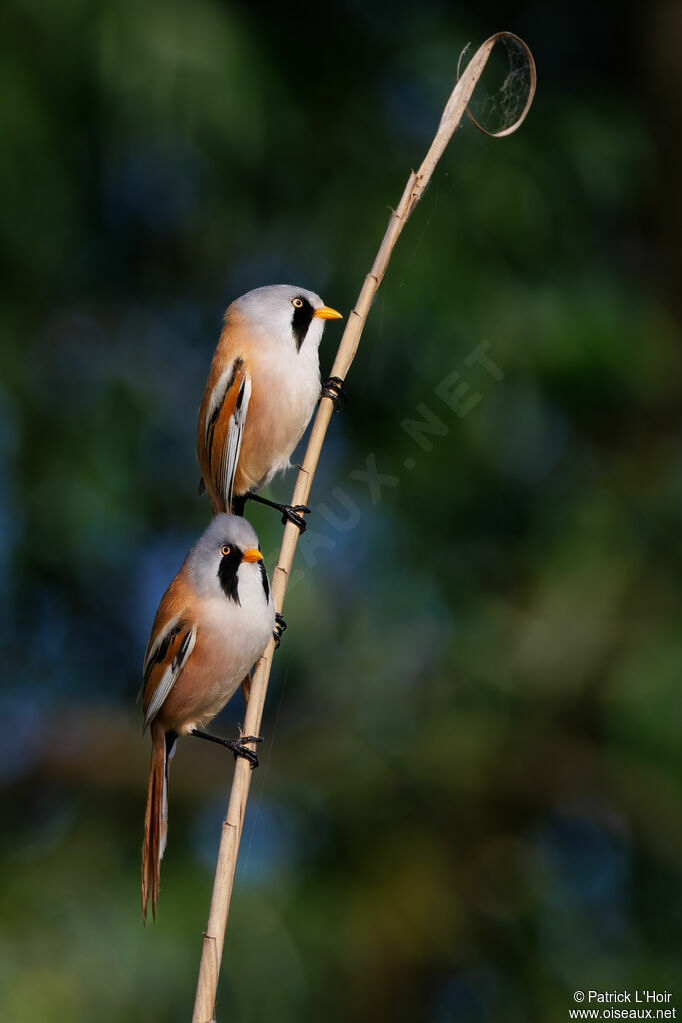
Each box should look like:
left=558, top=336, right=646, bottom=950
left=196, top=311, right=252, bottom=515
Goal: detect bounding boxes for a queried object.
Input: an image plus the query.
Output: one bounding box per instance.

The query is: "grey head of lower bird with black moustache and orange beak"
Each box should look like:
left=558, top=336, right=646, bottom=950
left=187, top=515, right=269, bottom=604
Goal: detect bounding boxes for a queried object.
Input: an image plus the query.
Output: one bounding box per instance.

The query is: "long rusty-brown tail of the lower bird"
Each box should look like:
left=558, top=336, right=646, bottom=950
left=142, top=721, right=171, bottom=923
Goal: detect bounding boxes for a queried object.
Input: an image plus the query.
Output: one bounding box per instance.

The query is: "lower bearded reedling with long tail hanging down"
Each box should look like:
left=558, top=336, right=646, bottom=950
left=142, top=515, right=275, bottom=920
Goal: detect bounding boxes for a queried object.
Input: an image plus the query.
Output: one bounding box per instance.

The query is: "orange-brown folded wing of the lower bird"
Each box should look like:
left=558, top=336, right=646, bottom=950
left=142, top=570, right=196, bottom=730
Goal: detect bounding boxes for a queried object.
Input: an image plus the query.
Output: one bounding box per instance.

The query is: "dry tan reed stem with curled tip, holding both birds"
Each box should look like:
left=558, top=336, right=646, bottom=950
left=192, top=32, right=536, bottom=1023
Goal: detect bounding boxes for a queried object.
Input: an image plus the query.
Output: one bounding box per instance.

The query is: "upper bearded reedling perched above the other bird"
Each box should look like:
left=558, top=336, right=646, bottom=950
left=196, top=284, right=343, bottom=530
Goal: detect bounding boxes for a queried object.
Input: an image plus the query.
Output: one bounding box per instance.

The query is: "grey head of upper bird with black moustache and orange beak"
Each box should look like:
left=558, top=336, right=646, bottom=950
left=233, top=284, right=340, bottom=352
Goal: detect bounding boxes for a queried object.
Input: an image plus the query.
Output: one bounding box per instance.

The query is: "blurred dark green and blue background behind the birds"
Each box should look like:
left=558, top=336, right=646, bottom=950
left=0, top=0, right=682, bottom=1023
